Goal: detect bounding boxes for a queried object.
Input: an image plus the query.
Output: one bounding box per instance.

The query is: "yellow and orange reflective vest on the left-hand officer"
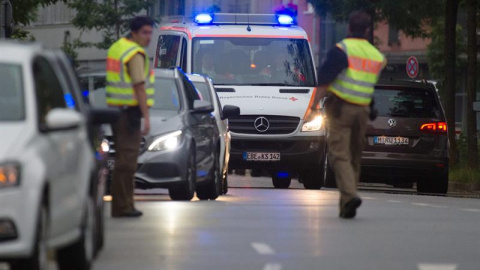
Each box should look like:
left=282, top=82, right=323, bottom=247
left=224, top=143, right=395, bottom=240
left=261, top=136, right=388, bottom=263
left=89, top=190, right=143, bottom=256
left=105, top=38, right=155, bottom=107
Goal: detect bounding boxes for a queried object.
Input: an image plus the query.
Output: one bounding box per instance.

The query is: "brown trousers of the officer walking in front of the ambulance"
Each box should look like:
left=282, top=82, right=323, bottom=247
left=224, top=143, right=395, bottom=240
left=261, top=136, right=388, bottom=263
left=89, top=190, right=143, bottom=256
left=327, top=98, right=370, bottom=210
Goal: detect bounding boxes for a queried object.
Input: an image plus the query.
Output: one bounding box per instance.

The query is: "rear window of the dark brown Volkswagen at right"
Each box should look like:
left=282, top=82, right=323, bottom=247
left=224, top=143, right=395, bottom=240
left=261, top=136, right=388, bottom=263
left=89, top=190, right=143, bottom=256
left=373, top=88, right=440, bottom=118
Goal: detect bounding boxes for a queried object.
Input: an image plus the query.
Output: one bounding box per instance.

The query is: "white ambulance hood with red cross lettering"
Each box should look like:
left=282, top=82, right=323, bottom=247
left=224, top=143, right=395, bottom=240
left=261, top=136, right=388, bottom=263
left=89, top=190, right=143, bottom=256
left=215, top=85, right=313, bottom=118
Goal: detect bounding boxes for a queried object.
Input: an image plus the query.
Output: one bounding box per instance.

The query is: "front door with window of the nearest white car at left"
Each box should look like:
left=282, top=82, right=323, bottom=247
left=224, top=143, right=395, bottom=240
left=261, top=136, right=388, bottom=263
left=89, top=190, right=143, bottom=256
left=33, top=57, right=83, bottom=238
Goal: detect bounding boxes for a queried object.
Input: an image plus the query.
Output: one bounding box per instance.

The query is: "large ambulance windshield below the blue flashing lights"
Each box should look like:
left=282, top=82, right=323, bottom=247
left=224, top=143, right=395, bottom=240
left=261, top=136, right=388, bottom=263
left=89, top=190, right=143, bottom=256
left=192, top=37, right=315, bottom=86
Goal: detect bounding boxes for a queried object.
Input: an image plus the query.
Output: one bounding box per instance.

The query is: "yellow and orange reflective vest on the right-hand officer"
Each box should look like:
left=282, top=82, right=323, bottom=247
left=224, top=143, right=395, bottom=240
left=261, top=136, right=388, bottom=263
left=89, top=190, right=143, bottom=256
left=327, top=38, right=385, bottom=106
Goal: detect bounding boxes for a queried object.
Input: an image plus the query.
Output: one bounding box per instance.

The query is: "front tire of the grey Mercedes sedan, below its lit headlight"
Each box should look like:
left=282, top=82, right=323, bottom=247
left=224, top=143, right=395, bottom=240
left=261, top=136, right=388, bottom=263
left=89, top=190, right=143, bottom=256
left=168, top=151, right=197, bottom=201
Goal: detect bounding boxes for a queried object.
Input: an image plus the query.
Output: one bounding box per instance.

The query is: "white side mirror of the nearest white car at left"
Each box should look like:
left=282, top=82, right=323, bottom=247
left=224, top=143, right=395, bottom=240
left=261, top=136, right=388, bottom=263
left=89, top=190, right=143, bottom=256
left=42, top=108, right=83, bottom=132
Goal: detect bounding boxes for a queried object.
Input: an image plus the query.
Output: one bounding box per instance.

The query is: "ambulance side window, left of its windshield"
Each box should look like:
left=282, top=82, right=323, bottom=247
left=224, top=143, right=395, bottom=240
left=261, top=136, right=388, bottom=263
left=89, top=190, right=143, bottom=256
left=154, top=35, right=180, bottom=68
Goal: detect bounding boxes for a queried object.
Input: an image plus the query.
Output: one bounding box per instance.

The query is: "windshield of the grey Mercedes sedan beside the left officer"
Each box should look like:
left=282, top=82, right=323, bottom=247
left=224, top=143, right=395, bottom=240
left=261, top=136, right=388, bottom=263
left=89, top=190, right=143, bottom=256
left=151, top=77, right=181, bottom=111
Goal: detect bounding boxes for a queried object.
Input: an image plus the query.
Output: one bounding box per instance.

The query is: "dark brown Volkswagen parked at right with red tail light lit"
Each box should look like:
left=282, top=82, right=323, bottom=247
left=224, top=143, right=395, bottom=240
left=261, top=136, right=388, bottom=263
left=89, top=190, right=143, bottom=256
left=361, top=81, right=449, bottom=193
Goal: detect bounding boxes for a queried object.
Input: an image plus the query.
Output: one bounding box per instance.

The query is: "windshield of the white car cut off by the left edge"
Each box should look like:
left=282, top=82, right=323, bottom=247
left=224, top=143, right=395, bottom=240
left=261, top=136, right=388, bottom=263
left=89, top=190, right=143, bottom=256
left=0, top=63, right=25, bottom=121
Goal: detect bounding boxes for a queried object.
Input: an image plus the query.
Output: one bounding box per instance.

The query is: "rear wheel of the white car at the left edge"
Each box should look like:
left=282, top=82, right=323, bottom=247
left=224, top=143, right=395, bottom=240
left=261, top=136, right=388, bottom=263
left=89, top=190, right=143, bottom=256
left=57, top=195, right=96, bottom=270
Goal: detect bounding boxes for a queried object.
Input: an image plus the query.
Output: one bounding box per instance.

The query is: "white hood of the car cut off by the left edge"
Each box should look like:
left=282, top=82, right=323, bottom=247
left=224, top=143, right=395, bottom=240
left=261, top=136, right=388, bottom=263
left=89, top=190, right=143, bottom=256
left=0, top=122, right=31, bottom=162
